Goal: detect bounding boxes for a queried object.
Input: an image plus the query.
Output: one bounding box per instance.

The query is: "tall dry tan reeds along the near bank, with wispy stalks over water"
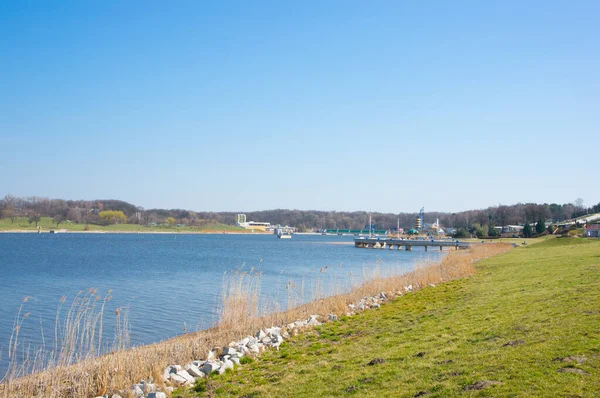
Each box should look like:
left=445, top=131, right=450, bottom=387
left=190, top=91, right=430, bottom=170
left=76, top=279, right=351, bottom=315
left=0, top=244, right=512, bottom=398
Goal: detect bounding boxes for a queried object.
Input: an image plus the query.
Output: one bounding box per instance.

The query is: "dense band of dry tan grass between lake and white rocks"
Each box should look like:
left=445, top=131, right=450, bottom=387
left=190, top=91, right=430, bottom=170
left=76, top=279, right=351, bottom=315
left=0, top=244, right=511, bottom=397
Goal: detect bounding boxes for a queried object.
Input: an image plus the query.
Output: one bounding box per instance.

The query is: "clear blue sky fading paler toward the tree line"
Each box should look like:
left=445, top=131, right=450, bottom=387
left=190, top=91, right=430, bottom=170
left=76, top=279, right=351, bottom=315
left=0, top=1, right=600, bottom=212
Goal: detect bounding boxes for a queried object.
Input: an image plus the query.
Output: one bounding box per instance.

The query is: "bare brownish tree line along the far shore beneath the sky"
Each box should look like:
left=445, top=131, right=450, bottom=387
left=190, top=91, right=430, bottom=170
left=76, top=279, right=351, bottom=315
left=0, top=195, right=600, bottom=232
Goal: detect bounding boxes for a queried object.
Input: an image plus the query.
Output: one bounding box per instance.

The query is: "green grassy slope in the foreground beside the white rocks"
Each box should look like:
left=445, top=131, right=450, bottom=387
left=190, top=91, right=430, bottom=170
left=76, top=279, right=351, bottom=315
left=182, top=238, right=600, bottom=397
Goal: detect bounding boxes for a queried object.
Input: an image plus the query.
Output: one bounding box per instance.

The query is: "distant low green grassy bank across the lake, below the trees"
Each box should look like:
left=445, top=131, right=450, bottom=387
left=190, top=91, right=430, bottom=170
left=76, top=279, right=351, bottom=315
left=0, top=217, right=252, bottom=233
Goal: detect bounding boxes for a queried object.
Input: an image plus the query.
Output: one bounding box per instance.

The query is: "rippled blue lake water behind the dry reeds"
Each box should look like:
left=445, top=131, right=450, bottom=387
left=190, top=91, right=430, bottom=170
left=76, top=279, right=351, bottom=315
left=0, top=233, right=440, bottom=378
